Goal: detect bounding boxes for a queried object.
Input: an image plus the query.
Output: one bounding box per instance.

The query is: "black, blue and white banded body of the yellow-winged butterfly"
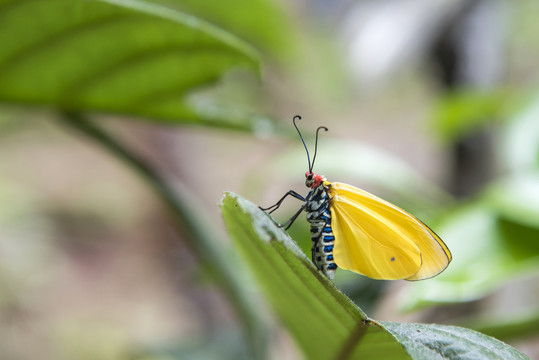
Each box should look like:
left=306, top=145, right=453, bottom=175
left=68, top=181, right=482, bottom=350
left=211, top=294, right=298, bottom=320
left=305, top=184, right=337, bottom=279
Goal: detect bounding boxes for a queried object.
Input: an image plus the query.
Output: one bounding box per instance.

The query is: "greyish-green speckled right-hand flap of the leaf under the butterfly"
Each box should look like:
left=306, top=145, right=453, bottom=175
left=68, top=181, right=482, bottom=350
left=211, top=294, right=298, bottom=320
left=382, top=321, right=528, bottom=360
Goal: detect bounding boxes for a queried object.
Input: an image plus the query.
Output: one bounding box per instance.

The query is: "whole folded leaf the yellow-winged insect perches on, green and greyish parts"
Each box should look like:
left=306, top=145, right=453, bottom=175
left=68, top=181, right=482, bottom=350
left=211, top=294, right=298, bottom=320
left=221, top=193, right=525, bottom=360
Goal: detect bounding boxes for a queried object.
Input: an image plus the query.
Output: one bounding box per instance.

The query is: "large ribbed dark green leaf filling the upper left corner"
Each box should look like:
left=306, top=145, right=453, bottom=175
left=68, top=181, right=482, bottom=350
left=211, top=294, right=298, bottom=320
left=0, top=0, right=259, bottom=127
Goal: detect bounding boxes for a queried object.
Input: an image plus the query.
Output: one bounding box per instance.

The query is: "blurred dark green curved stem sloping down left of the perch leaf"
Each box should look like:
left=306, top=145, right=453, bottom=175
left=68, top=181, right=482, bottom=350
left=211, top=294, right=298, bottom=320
left=61, top=112, right=266, bottom=359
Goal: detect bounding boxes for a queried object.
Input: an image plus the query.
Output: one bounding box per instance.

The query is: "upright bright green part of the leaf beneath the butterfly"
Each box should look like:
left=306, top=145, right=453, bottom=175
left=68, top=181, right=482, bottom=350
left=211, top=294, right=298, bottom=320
left=221, top=193, right=407, bottom=359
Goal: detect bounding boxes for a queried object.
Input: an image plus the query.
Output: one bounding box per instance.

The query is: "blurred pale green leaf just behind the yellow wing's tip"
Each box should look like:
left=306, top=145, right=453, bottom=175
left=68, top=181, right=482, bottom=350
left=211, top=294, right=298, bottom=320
left=402, top=202, right=510, bottom=310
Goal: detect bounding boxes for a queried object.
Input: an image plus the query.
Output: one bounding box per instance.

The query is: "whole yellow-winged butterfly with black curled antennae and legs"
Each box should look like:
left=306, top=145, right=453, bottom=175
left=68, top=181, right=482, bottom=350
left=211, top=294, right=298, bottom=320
left=261, top=115, right=452, bottom=280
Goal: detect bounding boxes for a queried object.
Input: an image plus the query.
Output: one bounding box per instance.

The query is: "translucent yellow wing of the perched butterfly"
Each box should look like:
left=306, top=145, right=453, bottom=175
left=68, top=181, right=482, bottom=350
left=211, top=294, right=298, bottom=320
left=326, top=182, right=451, bottom=280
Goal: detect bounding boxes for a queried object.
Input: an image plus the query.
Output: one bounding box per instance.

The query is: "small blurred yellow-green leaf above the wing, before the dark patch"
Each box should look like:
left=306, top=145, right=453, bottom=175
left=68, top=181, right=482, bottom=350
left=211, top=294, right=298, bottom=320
left=433, top=90, right=508, bottom=141
